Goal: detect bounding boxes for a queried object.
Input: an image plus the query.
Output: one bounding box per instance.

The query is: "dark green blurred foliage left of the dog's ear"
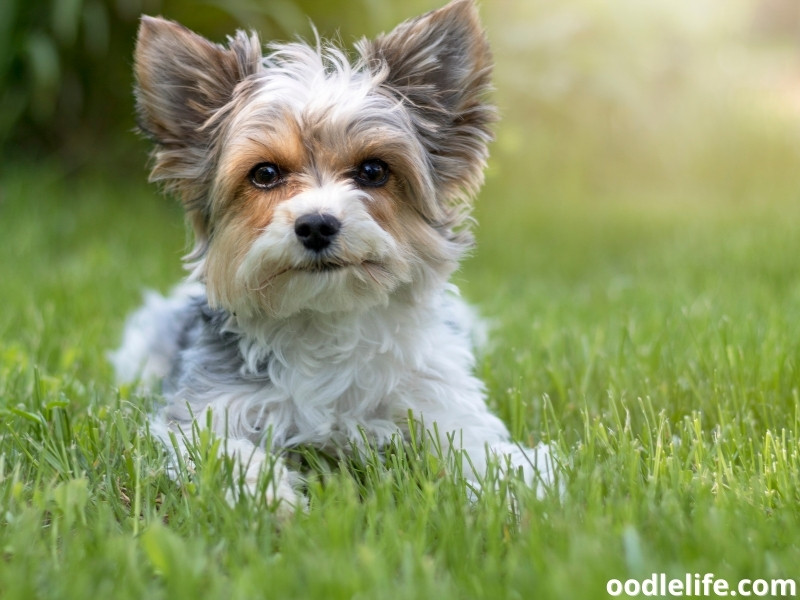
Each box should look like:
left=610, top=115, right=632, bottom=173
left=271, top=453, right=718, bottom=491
left=0, top=0, right=139, bottom=162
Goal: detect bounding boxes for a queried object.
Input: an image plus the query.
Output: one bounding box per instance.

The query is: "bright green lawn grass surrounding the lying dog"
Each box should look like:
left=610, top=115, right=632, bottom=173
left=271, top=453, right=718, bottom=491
left=0, top=2, right=800, bottom=600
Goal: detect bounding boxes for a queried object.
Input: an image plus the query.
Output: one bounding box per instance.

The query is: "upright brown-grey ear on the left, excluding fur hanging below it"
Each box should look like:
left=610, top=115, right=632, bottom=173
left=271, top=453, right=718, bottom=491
left=135, top=16, right=261, bottom=147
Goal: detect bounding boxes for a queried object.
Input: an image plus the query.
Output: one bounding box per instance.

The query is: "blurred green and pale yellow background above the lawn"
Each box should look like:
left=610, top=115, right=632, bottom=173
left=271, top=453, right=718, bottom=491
left=0, top=0, right=800, bottom=185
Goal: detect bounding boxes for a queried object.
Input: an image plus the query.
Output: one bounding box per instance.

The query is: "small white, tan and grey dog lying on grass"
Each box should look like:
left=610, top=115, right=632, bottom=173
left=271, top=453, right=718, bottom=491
left=112, top=0, right=552, bottom=510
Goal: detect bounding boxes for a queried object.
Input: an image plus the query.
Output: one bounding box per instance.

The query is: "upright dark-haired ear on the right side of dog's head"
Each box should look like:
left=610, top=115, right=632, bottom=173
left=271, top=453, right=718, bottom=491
left=357, top=0, right=495, bottom=200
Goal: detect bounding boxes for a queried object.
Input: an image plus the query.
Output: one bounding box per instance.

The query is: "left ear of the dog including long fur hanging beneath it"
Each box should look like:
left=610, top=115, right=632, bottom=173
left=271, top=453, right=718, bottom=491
left=134, top=16, right=262, bottom=247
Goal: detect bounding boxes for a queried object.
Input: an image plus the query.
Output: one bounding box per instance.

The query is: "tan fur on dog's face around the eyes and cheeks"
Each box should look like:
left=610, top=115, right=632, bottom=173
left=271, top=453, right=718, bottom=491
left=202, top=85, right=472, bottom=311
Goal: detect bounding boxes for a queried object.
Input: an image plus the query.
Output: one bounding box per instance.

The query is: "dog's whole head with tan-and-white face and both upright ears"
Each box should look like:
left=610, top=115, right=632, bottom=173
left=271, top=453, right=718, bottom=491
left=136, top=0, right=493, bottom=318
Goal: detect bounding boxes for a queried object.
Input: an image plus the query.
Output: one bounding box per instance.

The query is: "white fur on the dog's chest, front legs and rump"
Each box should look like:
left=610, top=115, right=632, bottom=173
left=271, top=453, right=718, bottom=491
left=114, top=286, right=553, bottom=506
